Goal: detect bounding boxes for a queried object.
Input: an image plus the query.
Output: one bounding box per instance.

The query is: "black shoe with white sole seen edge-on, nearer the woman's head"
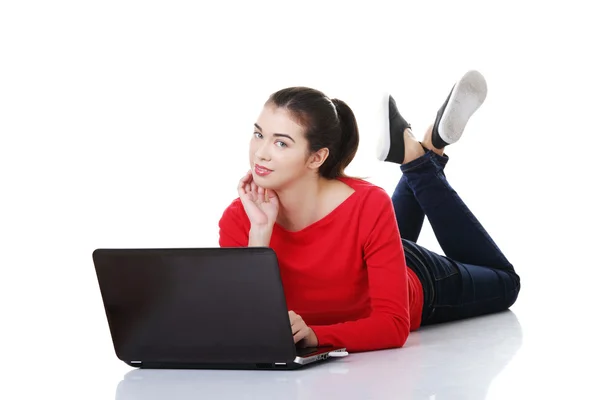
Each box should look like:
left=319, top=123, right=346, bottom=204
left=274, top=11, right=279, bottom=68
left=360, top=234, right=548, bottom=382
left=377, top=94, right=410, bottom=164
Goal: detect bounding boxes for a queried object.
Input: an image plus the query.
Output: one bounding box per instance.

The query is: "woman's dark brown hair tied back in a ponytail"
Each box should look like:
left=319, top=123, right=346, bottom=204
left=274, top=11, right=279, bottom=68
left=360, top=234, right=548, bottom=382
left=265, top=86, right=358, bottom=179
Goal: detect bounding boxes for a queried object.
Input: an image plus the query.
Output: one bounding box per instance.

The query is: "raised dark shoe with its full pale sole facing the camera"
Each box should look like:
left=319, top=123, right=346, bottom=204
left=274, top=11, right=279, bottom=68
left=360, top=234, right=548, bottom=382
left=431, top=71, right=487, bottom=149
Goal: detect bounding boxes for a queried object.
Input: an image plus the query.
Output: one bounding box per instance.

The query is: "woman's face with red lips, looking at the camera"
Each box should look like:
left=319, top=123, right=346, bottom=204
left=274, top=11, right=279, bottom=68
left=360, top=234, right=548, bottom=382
left=249, top=105, right=309, bottom=190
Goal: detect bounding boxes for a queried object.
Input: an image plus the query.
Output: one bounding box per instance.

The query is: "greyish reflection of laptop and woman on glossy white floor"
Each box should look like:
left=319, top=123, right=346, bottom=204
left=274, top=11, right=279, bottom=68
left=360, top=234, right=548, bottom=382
left=116, top=312, right=524, bottom=400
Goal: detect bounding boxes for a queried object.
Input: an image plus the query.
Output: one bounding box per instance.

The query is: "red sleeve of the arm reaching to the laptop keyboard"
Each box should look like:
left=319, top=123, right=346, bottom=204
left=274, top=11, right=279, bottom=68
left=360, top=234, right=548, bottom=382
left=311, top=188, right=410, bottom=351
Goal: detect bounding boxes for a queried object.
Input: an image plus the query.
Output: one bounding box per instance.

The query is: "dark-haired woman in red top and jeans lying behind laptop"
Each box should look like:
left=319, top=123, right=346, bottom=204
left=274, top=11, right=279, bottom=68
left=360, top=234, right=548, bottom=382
left=219, top=71, right=520, bottom=352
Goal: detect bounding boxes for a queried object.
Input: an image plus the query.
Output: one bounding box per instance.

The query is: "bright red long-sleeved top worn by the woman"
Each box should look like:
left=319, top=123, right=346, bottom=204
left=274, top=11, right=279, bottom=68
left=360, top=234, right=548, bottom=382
left=219, top=178, right=423, bottom=352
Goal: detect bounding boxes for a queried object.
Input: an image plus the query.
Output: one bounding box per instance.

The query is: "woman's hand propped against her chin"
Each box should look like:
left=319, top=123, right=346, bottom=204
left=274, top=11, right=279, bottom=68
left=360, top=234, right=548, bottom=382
left=238, top=171, right=279, bottom=228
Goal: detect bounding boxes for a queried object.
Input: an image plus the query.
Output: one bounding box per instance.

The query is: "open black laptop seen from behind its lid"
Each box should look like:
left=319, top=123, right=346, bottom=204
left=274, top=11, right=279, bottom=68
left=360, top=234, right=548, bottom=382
left=92, top=247, right=348, bottom=369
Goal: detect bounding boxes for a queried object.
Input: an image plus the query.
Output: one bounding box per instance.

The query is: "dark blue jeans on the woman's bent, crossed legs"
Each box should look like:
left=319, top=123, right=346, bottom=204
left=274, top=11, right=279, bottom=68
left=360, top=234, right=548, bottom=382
left=392, top=151, right=521, bottom=325
